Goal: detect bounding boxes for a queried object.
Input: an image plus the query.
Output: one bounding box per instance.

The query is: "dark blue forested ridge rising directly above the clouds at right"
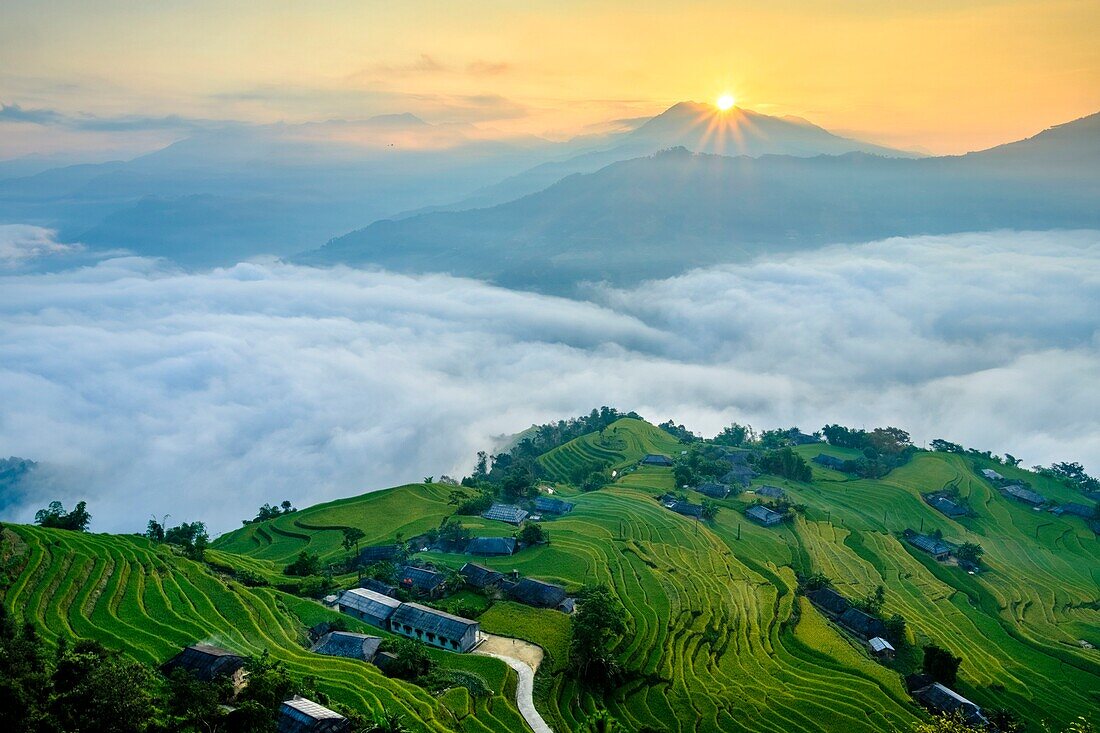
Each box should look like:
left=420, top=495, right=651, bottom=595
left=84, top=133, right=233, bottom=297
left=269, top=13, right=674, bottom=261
left=303, top=114, right=1100, bottom=291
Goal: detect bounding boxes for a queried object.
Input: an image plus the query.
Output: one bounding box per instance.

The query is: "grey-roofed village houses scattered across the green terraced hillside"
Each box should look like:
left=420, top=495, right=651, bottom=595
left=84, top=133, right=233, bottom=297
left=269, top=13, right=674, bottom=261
left=141, top=424, right=1100, bottom=733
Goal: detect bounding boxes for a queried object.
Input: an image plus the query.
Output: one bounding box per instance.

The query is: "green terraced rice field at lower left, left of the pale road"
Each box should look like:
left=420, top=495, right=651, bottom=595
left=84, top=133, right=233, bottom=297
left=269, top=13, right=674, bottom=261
left=4, top=526, right=524, bottom=732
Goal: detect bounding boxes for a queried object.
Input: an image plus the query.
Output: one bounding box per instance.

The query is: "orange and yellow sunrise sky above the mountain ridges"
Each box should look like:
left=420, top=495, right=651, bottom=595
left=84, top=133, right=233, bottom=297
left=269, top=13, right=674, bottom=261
left=0, top=0, right=1100, bottom=157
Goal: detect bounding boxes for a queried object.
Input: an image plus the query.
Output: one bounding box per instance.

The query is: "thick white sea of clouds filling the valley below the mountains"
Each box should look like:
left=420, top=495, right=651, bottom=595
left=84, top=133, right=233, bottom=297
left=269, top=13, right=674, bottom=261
left=0, top=229, right=1100, bottom=532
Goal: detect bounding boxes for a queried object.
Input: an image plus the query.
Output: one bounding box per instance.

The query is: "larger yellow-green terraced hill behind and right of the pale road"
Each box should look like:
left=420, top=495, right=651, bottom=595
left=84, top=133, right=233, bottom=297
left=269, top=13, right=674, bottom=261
left=216, top=420, right=1100, bottom=733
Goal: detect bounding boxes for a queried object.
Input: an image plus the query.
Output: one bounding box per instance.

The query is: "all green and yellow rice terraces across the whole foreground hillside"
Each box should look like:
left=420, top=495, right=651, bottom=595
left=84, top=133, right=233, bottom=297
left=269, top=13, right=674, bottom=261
left=4, top=417, right=1100, bottom=733
